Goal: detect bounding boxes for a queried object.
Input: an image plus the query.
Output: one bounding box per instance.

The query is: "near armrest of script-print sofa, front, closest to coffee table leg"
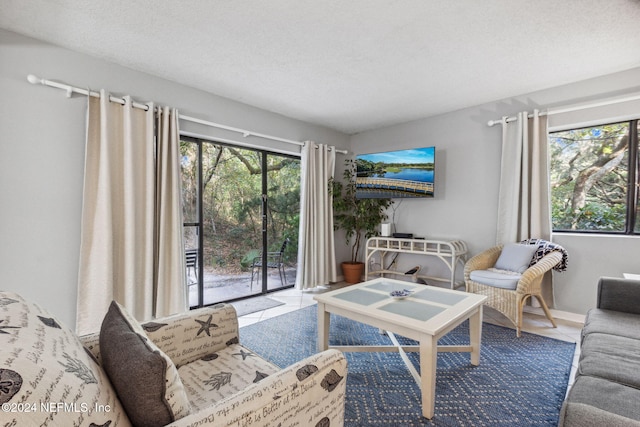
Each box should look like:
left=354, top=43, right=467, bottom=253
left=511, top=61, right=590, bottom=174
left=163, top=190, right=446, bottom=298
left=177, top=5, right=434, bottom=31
left=165, top=350, right=347, bottom=427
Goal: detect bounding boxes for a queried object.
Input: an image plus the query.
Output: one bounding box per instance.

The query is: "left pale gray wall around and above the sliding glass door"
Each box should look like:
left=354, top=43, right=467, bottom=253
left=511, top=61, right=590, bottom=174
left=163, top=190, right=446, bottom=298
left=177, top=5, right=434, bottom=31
left=0, top=29, right=349, bottom=326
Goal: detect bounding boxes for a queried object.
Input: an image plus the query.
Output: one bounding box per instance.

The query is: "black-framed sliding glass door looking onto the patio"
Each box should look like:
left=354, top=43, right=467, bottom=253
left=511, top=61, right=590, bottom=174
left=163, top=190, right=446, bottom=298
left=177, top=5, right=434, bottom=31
left=181, top=137, right=300, bottom=307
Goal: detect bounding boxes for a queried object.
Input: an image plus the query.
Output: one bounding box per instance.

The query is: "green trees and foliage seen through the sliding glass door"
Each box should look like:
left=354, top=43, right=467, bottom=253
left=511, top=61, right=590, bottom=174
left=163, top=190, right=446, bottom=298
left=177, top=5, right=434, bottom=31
left=180, top=141, right=300, bottom=274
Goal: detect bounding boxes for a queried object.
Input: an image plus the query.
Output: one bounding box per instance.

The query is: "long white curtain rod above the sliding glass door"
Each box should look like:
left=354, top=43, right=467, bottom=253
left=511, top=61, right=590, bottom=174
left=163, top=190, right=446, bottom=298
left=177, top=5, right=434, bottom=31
left=27, top=74, right=348, bottom=154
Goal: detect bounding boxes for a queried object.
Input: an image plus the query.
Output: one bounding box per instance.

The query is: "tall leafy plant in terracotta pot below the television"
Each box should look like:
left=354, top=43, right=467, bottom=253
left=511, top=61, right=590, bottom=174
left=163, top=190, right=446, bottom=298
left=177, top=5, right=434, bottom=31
left=329, top=159, right=393, bottom=283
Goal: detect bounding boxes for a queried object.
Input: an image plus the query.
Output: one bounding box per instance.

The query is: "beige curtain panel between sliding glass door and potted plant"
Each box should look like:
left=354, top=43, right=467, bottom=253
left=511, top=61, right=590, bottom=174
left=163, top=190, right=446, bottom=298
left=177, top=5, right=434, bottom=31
left=296, top=141, right=337, bottom=289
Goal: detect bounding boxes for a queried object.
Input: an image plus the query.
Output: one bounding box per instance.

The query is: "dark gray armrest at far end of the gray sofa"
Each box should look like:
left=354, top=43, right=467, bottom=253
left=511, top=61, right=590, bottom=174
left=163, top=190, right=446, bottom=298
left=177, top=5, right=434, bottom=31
left=597, top=277, right=640, bottom=314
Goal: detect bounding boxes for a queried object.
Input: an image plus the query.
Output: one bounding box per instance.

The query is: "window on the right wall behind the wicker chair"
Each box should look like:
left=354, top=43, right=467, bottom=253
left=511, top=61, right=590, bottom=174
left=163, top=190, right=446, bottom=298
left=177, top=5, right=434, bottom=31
left=549, top=120, right=640, bottom=234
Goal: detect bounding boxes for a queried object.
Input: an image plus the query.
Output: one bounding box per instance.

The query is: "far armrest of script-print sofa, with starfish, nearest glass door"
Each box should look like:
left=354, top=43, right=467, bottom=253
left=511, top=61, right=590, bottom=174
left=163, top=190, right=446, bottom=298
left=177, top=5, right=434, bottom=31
left=142, top=304, right=239, bottom=367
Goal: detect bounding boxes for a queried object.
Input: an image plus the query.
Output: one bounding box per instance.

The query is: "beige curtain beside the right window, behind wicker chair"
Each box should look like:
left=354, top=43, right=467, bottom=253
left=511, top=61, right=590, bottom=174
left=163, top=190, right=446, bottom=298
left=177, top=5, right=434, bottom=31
left=496, top=110, right=553, bottom=306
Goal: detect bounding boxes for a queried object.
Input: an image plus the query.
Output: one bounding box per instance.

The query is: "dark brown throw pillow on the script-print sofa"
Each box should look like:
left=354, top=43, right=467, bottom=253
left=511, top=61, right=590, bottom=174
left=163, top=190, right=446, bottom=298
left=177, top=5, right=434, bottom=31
left=100, top=301, right=191, bottom=426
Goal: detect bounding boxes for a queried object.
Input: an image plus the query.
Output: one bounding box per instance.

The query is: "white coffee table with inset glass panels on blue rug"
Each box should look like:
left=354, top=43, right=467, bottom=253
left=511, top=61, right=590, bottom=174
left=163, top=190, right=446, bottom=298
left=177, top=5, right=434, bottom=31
left=314, top=278, right=487, bottom=419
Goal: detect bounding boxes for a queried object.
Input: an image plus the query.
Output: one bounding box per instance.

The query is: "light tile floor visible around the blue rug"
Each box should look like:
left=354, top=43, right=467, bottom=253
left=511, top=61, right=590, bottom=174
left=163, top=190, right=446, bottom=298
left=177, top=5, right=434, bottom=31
left=238, top=283, right=582, bottom=387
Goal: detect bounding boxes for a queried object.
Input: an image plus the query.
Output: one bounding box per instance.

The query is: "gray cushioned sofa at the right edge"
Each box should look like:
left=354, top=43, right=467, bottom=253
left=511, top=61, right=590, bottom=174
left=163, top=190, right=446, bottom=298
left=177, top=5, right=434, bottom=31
left=560, top=277, right=640, bottom=427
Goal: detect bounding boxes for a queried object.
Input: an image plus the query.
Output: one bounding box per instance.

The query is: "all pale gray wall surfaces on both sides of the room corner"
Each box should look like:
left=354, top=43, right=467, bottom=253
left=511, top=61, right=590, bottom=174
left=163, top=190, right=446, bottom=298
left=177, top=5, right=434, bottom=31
left=5, top=30, right=640, bottom=325
